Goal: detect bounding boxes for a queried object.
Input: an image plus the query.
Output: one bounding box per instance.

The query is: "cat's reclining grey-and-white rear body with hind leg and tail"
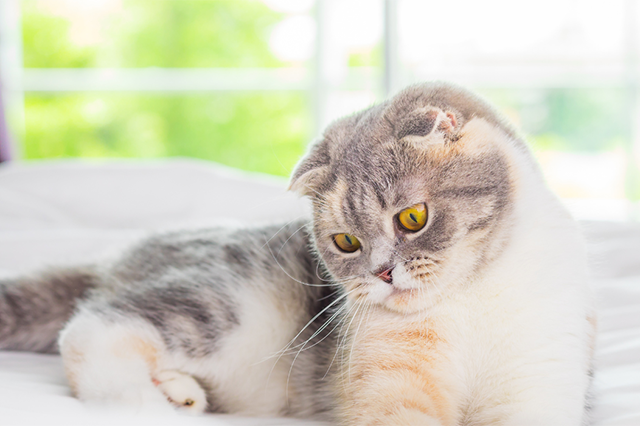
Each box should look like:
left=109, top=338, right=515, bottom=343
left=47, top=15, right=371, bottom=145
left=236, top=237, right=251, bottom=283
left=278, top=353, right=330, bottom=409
left=0, top=221, right=339, bottom=417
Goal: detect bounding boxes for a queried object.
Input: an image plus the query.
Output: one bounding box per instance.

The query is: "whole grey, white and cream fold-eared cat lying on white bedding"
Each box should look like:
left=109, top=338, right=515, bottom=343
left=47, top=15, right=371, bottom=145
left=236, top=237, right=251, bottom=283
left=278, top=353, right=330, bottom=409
left=0, top=82, right=596, bottom=426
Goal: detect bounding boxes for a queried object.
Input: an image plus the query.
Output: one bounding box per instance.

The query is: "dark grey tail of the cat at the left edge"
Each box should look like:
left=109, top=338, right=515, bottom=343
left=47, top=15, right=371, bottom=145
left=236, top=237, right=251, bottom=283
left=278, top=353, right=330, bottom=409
left=0, top=267, right=98, bottom=353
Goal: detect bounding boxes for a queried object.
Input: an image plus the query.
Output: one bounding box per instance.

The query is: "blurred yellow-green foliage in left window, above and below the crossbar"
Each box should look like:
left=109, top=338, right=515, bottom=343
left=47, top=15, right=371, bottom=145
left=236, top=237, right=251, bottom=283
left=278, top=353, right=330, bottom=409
left=22, top=0, right=311, bottom=175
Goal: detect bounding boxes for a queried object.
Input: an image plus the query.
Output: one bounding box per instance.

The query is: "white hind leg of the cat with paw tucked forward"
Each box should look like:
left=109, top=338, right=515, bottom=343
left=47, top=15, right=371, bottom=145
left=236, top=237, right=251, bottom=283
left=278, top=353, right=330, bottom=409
left=59, top=312, right=206, bottom=414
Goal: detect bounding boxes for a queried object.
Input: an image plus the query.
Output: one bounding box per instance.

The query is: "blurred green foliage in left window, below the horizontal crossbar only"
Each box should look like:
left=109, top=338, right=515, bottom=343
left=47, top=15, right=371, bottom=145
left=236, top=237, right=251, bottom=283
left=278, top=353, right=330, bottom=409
left=24, top=93, right=310, bottom=176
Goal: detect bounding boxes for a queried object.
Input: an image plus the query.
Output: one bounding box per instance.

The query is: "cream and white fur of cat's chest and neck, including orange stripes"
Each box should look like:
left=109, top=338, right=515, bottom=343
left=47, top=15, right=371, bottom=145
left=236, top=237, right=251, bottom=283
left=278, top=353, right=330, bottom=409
left=338, top=119, right=595, bottom=426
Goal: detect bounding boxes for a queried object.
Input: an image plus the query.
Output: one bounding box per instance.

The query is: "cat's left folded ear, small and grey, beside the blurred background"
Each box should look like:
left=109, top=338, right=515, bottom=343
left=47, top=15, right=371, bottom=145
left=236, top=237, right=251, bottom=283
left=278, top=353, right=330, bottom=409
left=289, top=141, right=330, bottom=196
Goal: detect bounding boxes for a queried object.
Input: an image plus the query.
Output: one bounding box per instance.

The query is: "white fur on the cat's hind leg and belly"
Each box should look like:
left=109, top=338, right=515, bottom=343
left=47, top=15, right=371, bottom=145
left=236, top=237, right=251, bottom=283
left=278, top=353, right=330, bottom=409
left=60, top=282, right=312, bottom=416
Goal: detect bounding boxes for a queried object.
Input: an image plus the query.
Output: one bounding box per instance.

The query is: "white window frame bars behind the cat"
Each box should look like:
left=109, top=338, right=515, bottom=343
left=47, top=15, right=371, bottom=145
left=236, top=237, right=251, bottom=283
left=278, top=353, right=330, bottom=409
left=0, top=0, right=640, bottom=217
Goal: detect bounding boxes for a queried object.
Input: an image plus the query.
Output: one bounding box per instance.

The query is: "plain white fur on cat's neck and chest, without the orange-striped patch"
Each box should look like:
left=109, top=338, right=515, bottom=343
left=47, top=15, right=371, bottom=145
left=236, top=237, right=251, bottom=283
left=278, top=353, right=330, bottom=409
left=348, top=119, right=594, bottom=426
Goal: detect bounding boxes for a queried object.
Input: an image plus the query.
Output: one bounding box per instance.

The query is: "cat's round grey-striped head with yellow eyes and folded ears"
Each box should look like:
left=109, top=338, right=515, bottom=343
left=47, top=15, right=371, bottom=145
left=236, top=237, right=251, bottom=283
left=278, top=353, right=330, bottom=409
left=291, top=84, right=526, bottom=313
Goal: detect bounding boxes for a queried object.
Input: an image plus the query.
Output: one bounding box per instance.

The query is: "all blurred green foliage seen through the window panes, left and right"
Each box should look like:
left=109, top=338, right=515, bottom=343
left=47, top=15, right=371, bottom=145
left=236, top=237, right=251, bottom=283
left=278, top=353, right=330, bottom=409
left=21, top=0, right=631, bottom=188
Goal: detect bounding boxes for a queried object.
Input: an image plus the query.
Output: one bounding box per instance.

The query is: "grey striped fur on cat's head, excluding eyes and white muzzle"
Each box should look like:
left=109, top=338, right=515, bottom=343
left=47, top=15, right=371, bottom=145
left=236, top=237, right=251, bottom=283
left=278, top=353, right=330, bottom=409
left=292, top=83, right=528, bottom=312
